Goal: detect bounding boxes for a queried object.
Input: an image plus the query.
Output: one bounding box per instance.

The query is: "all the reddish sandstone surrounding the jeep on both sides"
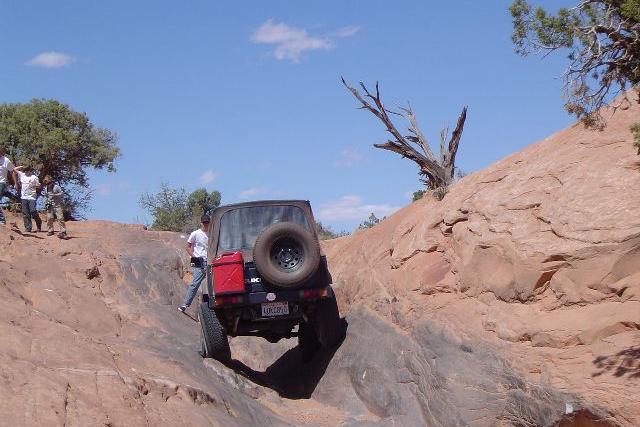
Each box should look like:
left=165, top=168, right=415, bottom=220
left=0, top=101, right=640, bottom=427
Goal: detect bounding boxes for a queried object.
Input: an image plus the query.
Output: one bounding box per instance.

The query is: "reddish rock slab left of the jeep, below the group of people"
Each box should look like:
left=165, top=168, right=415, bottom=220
left=0, top=222, right=292, bottom=426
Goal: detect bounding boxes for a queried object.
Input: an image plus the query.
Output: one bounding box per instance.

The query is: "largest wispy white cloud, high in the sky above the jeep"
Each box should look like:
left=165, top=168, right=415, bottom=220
left=250, top=19, right=360, bottom=62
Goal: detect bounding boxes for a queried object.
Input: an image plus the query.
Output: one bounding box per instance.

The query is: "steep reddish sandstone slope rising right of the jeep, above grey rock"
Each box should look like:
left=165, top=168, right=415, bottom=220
left=325, top=99, right=640, bottom=425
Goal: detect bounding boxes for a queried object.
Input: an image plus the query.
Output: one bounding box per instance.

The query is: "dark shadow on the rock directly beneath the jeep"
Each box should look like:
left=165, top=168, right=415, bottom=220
left=228, top=319, right=348, bottom=399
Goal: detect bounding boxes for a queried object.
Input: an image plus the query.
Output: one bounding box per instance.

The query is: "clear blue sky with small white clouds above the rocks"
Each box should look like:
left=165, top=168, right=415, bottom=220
left=0, top=0, right=573, bottom=230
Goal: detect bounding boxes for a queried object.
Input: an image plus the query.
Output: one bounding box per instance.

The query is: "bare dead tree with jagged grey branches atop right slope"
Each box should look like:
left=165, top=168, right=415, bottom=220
left=342, top=78, right=467, bottom=195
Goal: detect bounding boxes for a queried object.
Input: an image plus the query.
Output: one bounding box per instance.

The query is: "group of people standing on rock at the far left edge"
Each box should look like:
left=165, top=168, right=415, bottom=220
left=0, top=146, right=67, bottom=239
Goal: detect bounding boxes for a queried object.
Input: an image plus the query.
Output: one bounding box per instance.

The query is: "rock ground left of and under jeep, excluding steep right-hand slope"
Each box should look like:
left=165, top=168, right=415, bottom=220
left=0, top=222, right=610, bottom=426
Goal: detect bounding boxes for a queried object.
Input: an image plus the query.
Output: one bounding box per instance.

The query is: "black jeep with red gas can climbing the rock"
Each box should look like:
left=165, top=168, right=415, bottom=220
left=198, top=200, right=343, bottom=362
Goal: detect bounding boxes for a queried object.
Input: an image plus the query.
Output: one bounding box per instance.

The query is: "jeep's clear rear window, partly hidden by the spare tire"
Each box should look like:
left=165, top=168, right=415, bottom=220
left=218, top=205, right=310, bottom=253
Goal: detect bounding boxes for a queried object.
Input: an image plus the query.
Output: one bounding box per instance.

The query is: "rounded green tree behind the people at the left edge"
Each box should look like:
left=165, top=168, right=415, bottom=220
left=0, top=99, right=120, bottom=217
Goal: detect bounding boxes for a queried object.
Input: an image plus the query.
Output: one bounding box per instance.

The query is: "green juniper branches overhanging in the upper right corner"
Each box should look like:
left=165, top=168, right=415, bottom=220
left=509, top=0, right=640, bottom=154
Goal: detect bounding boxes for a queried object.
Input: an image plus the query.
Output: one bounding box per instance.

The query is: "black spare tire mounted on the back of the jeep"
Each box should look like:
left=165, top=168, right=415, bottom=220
left=253, top=222, right=320, bottom=288
